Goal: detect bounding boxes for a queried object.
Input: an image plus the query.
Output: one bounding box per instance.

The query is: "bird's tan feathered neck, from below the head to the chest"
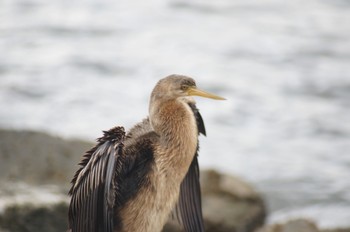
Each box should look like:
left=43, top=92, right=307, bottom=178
left=150, top=99, right=198, bottom=176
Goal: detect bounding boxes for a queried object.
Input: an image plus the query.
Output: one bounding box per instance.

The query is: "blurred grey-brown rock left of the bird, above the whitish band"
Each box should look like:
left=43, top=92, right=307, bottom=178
left=0, top=129, right=92, bottom=187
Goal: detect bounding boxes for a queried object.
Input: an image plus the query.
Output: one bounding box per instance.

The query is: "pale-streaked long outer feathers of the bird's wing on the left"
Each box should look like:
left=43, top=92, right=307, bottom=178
left=68, top=127, right=125, bottom=232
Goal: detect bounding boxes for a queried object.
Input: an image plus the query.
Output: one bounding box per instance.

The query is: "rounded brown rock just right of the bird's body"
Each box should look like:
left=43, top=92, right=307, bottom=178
left=163, top=170, right=266, bottom=232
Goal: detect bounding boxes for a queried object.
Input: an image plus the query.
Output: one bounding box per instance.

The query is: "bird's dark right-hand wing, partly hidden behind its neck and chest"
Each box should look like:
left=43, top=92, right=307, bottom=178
left=176, top=104, right=206, bottom=232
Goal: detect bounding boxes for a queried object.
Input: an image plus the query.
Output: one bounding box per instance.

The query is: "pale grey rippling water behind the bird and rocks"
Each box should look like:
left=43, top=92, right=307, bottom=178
left=0, top=0, right=350, bottom=227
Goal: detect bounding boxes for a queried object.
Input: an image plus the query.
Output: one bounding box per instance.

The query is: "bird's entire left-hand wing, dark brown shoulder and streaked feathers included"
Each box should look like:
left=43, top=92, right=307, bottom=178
left=69, top=124, right=158, bottom=232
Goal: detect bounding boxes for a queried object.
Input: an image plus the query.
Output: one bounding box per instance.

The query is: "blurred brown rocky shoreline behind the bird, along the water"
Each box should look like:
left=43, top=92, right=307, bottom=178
left=0, top=129, right=350, bottom=232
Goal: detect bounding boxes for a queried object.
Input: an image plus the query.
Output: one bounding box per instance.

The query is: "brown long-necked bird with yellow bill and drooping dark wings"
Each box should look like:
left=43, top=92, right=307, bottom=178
left=68, top=74, right=225, bottom=232
